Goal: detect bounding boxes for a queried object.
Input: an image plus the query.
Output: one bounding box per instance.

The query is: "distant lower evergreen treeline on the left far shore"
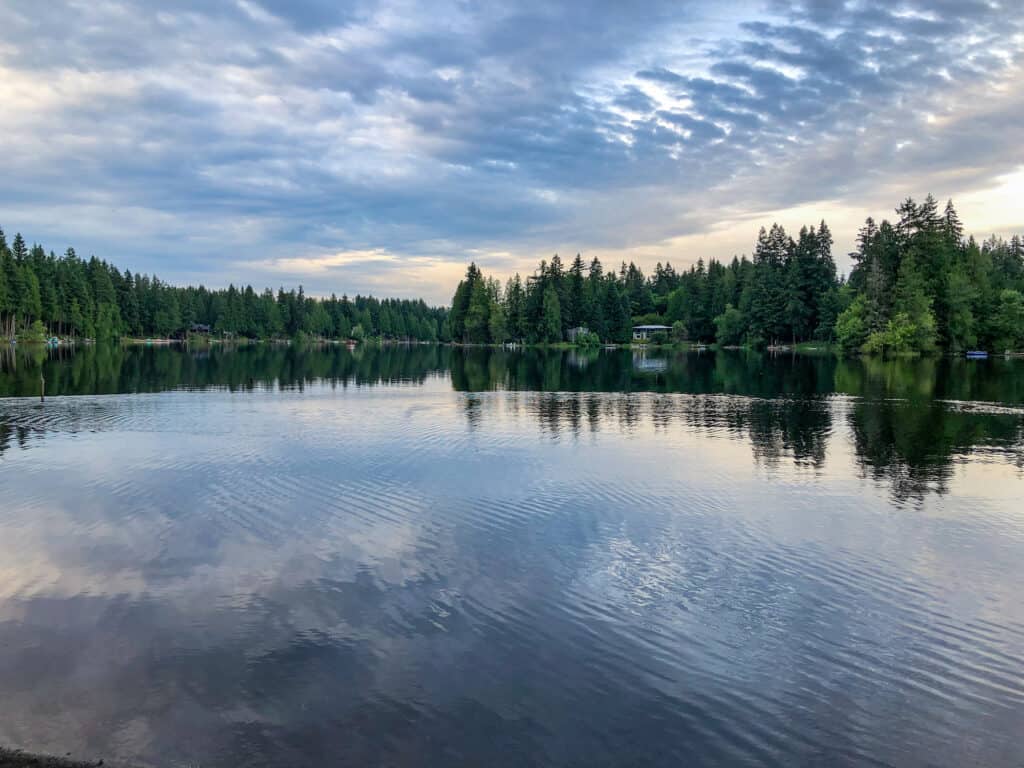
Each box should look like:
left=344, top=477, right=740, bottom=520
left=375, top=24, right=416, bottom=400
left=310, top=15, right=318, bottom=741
left=0, top=229, right=450, bottom=341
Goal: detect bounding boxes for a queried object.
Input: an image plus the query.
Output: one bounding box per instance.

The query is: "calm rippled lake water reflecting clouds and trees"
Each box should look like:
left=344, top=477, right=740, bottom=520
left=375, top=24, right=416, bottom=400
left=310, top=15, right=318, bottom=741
left=0, top=346, right=1024, bottom=768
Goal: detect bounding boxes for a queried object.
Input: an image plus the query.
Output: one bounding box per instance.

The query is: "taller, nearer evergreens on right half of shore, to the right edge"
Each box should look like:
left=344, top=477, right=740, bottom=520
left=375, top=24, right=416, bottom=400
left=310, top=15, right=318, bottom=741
left=450, top=196, right=1024, bottom=352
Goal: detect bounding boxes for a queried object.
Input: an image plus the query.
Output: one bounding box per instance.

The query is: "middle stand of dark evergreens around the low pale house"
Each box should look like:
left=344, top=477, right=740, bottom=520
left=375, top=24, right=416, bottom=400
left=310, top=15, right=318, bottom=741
left=450, top=222, right=843, bottom=345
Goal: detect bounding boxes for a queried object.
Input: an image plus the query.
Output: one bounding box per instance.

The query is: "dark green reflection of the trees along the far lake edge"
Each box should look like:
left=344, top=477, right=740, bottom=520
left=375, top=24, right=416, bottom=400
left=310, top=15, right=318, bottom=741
left=0, top=344, right=1024, bottom=499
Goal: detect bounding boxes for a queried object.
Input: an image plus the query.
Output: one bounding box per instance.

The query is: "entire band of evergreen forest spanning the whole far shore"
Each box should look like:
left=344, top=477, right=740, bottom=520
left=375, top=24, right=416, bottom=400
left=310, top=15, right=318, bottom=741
left=0, top=196, right=1024, bottom=353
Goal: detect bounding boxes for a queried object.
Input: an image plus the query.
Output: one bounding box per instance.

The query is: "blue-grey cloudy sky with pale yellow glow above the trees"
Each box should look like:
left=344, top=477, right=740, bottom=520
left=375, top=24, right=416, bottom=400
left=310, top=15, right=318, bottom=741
left=0, top=0, right=1024, bottom=303
